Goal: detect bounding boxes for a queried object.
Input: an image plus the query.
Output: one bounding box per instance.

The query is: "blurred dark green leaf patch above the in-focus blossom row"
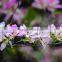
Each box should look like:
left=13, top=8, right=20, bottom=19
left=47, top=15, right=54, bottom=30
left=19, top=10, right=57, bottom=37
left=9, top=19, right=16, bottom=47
left=24, top=8, right=36, bottom=26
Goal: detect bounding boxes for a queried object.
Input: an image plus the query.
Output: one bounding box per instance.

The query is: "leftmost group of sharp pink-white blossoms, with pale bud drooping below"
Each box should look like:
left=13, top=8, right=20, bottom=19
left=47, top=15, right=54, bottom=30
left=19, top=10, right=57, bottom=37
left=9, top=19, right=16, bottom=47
left=0, top=22, right=27, bottom=50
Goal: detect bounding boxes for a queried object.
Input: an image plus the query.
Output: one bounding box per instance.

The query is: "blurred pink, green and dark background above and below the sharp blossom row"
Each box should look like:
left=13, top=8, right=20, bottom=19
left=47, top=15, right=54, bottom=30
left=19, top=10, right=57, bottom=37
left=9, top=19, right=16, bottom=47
left=0, top=0, right=62, bottom=62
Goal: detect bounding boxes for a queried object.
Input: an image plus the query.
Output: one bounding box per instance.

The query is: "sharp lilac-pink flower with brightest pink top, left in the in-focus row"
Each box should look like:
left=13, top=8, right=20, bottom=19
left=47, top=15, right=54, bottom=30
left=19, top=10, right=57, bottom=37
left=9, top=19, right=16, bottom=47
left=5, top=24, right=18, bottom=36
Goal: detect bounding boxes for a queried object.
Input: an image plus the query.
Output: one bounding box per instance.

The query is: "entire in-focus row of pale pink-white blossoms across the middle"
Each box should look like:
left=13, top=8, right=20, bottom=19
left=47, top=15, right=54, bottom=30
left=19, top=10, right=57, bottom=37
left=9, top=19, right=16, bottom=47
left=0, top=22, right=62, bottom=50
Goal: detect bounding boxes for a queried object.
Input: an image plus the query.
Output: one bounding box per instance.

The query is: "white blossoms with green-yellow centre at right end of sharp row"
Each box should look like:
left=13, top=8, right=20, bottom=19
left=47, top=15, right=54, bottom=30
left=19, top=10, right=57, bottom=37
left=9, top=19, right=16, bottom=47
left=50, top=25, right=62, bottom=44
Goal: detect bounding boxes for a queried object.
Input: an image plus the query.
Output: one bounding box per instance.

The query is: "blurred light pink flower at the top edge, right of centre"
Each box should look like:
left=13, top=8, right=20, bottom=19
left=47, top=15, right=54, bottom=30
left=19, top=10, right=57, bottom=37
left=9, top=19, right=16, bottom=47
left=32, top=0, right=59, bottom=10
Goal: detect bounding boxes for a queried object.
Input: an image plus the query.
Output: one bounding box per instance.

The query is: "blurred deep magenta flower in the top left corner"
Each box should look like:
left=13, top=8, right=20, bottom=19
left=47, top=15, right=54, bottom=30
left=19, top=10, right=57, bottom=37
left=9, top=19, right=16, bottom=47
left=0, top=0, right=18, bottom=21
